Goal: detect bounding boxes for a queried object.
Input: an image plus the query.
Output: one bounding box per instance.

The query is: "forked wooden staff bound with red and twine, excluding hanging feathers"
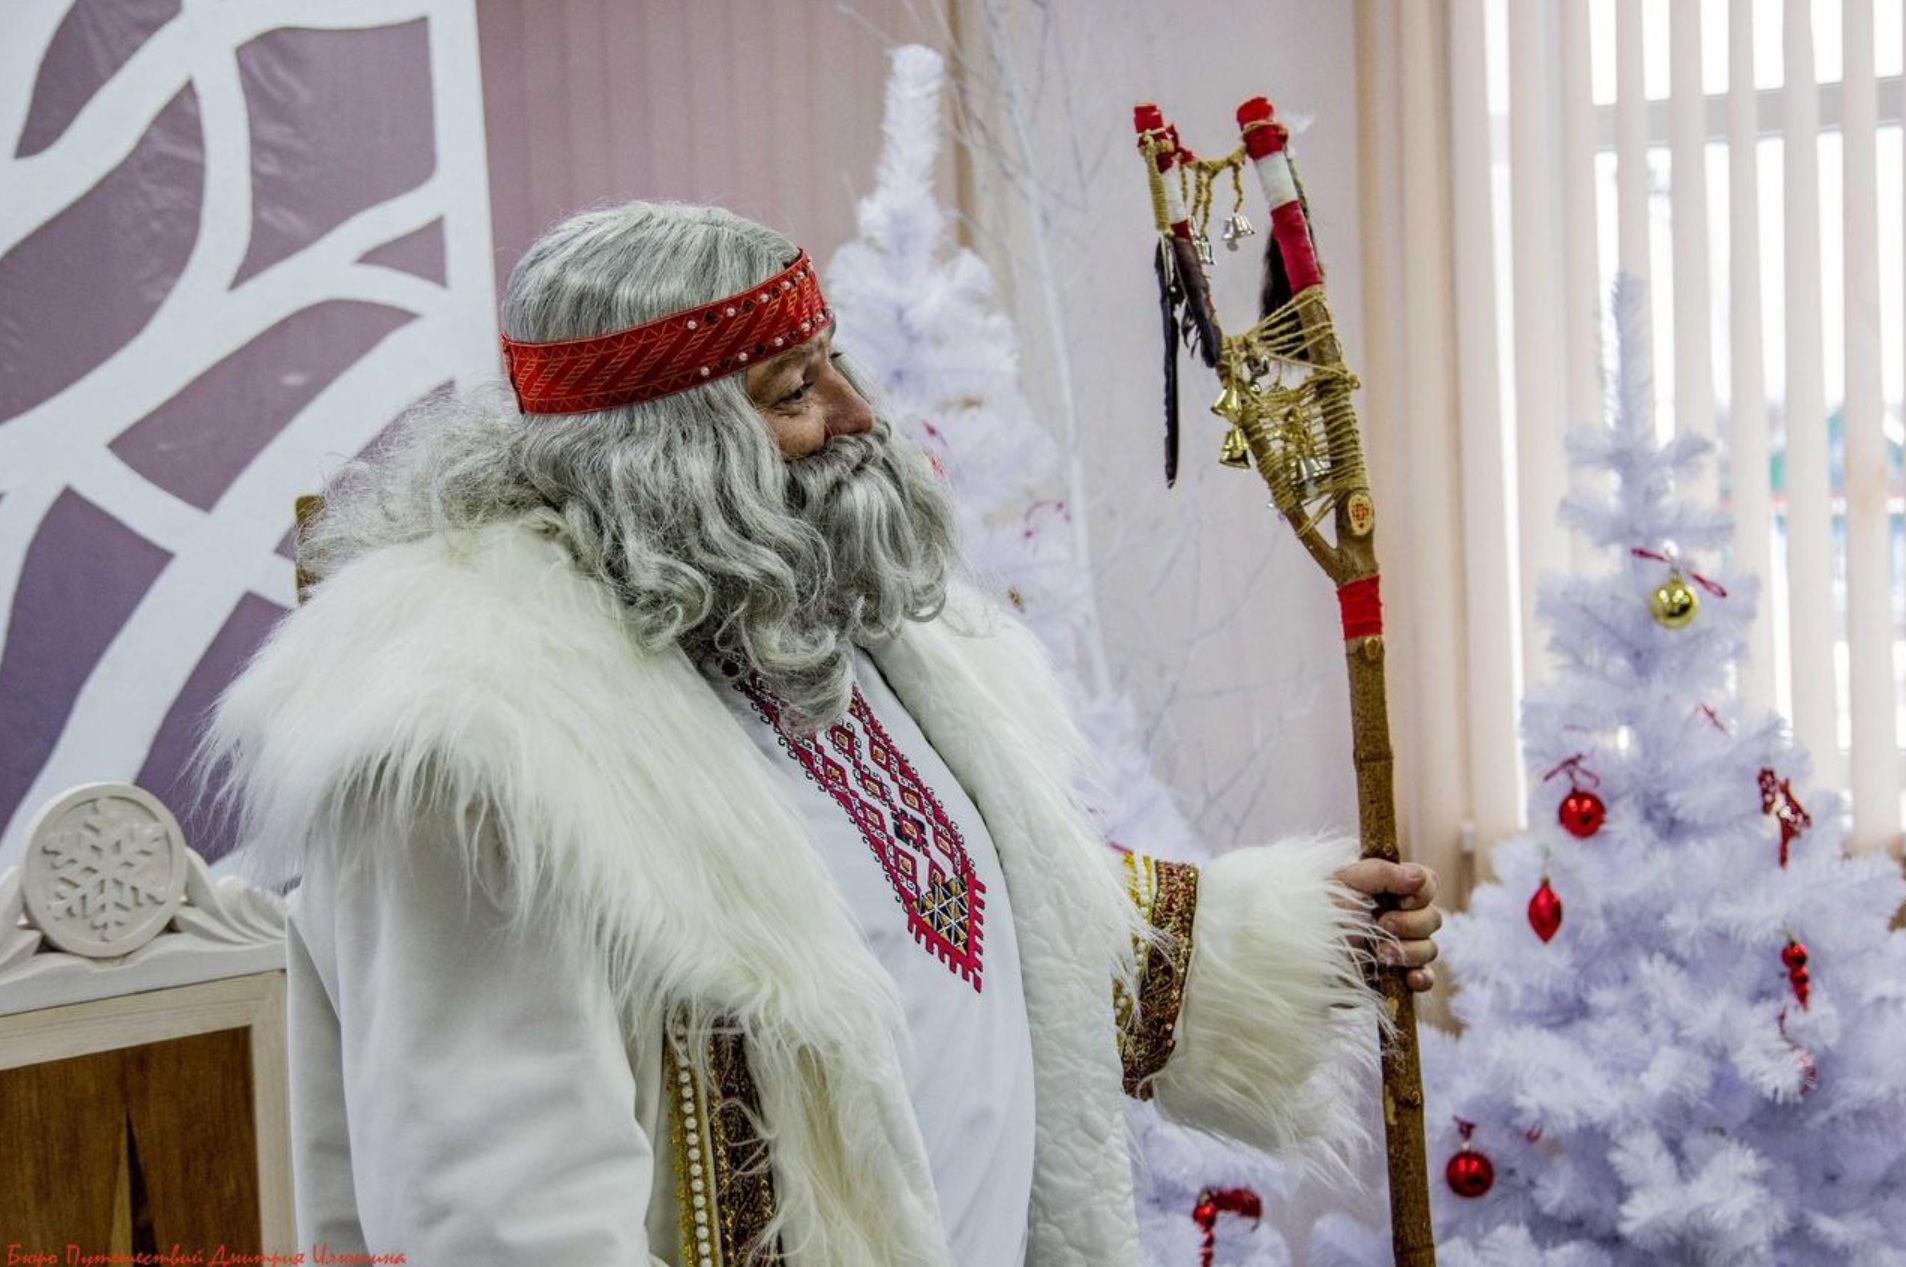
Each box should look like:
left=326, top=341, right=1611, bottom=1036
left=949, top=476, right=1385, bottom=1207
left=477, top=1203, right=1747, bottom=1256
left=1134, top=97, right=1435, bottom=1267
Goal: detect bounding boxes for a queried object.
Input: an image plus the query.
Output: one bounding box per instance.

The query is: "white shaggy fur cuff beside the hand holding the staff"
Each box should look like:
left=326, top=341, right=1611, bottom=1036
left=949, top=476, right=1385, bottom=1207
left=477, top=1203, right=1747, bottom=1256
left=1149, top=840, right=1380, bottom=1160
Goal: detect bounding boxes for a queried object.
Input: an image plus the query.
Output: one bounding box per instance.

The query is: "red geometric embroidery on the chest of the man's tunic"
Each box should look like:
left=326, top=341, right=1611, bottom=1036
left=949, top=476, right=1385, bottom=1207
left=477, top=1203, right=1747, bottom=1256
left=736, top=673, right=985, bottom=993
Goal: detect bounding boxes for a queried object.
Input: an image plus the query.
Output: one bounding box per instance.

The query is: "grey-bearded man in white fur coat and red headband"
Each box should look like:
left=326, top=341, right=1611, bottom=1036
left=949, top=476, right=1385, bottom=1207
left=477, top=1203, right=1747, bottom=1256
left=213, top=204, right=1441, bottom=1267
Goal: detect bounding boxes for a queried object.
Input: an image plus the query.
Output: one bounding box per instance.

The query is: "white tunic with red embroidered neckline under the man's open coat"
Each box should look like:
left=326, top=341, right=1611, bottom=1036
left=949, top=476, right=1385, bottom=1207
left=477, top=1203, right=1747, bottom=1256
left=724, top=652, right=1033, bottom=1263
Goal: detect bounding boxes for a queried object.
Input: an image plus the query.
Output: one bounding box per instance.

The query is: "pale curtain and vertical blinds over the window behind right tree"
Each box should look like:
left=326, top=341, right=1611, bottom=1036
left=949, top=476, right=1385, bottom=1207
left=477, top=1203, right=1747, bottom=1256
left=1359, top=0, right=1906, bottom=887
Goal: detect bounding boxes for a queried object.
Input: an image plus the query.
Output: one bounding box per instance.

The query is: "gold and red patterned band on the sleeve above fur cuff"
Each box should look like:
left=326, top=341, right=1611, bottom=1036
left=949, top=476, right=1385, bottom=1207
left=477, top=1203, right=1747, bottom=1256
left=1117, top=854, right=1197, bottom=1099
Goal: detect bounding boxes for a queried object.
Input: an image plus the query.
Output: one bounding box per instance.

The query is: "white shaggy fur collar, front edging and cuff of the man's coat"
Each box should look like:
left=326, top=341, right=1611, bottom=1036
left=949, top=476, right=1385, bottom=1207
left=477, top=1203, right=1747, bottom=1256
left=213, top=526, right=1374, bottom=1267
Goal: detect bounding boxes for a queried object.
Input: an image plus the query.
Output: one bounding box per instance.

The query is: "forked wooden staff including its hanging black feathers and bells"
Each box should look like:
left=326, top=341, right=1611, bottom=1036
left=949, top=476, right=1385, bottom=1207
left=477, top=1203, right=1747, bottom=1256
left=1132, top=97, right=1435, bottom=1267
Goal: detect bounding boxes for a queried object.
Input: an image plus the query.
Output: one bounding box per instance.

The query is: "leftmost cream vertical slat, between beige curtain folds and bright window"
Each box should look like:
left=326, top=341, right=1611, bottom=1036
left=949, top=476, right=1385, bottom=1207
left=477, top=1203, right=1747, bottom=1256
left=1449, top=0, right=1523, bottom=840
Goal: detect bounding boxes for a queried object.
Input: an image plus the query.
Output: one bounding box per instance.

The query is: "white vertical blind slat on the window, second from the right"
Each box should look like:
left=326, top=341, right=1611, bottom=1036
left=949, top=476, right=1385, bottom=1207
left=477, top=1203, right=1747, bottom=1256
left=1780, top=0, right=1843, bottom=787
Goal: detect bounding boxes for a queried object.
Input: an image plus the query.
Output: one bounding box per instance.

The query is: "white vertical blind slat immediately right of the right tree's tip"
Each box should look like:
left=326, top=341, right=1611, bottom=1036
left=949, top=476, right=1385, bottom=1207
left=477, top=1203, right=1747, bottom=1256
left=1668, top=0, right=1721, bottom=505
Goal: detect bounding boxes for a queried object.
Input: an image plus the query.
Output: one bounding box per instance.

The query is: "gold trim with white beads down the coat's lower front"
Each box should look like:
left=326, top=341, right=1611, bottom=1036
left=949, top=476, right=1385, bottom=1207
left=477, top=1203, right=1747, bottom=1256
left=661, top=1023, right=781, bottom=1267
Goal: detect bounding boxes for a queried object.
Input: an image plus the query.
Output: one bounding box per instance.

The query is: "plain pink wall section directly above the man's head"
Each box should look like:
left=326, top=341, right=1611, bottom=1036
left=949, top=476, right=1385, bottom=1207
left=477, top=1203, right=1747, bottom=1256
left=477, top=0, right=951, bottom=278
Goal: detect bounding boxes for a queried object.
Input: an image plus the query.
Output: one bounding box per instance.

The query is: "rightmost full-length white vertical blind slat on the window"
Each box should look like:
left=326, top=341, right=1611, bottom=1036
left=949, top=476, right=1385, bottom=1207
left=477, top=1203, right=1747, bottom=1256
left=1839, top=0, right=1900, bottom=848
